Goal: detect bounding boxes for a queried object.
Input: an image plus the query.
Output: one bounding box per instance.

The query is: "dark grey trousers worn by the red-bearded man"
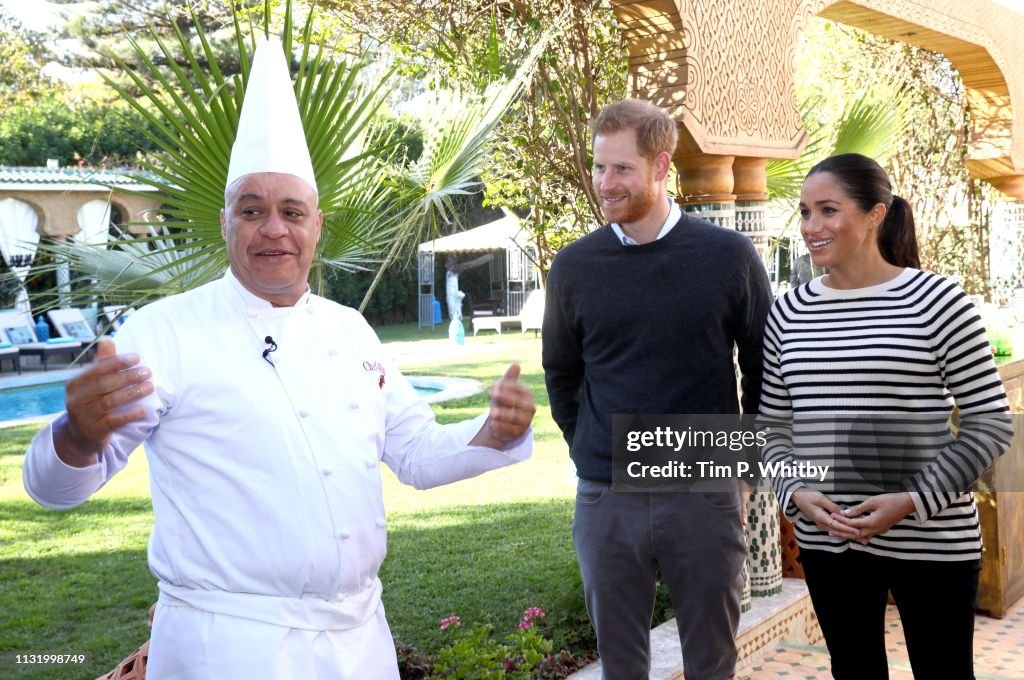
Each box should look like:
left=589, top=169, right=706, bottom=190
left=572, top=479, right=746, bottom=680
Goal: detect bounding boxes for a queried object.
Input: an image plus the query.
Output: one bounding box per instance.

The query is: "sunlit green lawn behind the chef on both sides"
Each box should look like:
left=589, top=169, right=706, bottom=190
left=0, top=325, right=586, bottom=680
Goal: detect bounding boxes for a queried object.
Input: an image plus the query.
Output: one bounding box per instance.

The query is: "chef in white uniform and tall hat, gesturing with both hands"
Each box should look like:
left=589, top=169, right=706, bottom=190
left=24, top=33, right=535, bottom=680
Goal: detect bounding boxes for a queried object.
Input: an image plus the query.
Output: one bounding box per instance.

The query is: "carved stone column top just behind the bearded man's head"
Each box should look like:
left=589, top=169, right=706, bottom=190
left=673, top=154, right=736, bottom=229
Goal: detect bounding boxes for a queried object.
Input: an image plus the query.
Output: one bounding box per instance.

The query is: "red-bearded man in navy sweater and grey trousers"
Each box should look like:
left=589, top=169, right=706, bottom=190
left=544, top=99, right=772, bottom=680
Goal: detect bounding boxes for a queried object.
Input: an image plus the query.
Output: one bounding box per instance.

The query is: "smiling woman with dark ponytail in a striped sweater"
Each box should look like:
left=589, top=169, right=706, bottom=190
left=761, top=154, right=1012, bottom=680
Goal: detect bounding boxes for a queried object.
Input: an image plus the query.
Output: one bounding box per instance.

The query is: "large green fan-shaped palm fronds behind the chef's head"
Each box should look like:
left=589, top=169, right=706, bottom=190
left=25, top=0, right=553, bottom=317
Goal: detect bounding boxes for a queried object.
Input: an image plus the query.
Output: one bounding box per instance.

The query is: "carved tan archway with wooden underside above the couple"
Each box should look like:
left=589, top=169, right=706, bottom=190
left=612, top=0, right=1024, bottom=196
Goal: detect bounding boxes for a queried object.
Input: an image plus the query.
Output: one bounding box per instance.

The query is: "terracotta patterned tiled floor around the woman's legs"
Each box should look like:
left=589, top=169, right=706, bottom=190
left=737, top=600, right=1024, bottom=680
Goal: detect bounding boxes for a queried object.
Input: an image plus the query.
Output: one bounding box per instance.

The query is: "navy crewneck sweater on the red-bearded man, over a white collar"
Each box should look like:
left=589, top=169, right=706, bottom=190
left=544, top=214, right=772, bottom=482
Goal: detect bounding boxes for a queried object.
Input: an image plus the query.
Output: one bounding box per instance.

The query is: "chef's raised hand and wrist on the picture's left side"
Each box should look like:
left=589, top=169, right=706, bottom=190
left=53, top=340, right=154, bottom=467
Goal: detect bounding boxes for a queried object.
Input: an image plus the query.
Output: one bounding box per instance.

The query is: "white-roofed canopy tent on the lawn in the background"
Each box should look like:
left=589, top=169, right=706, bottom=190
left=418, top=209, right=541, bottom=327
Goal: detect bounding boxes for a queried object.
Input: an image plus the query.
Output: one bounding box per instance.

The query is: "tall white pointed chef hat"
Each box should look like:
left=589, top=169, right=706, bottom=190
left=225, top=36, right=317, bottom=196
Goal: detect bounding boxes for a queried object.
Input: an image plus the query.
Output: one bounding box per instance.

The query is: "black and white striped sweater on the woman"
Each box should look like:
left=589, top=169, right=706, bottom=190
left=761, top=268, right=1013, bottom=560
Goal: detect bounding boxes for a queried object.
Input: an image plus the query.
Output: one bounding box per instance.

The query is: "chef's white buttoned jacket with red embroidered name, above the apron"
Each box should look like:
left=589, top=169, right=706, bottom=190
left=24, top=272, right=532, bottom=675
